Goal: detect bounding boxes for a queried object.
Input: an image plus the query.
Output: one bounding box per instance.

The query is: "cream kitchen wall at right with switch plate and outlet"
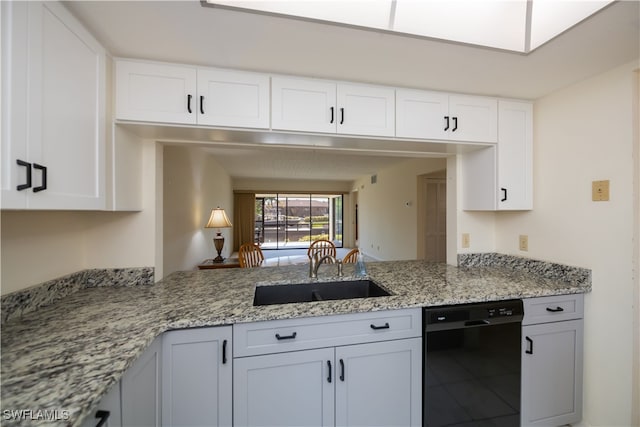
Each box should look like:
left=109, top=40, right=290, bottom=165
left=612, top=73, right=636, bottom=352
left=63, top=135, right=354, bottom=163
left=495, top=63, right=640, bottom=426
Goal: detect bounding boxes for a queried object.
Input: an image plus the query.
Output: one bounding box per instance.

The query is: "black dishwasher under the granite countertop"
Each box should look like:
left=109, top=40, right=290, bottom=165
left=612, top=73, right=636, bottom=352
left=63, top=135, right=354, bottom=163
left=423, top=300, right=523, bottom=427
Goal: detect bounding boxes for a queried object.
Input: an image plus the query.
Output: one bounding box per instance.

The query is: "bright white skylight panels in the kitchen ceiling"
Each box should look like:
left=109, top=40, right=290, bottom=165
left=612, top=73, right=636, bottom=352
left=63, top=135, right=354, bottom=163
left=203, top=0, right=613, bottom=53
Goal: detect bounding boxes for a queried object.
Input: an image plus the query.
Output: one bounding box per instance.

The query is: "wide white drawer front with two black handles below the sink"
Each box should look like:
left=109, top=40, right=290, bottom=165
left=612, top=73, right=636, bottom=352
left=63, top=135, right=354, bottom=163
left=233, top=308, right=422, bottom=357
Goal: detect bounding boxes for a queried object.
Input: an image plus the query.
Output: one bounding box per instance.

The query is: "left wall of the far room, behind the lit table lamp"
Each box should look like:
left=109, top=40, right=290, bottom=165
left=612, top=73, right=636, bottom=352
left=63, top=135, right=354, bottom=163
left=163, top=145, right=233, bottom=276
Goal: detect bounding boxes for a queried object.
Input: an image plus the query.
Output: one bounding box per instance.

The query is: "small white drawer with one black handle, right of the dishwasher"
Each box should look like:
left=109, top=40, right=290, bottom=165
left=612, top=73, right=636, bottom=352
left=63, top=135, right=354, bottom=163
left=522, top=294, right=584, bottom=325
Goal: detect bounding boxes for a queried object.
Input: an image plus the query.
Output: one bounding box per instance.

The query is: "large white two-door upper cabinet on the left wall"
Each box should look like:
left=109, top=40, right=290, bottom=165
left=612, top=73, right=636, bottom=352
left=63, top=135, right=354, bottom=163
left=2, top=2, right=106, bottom=210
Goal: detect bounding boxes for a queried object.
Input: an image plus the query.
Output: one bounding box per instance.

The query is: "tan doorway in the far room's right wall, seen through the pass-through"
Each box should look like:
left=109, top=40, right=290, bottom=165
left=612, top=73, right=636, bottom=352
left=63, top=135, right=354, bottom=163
left=417, top=170, right=447, bottom=262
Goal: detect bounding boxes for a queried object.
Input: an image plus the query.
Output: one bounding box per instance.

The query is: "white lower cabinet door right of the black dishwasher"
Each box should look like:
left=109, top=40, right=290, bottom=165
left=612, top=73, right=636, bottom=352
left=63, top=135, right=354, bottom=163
left=521, top=320, right=583, bottom=426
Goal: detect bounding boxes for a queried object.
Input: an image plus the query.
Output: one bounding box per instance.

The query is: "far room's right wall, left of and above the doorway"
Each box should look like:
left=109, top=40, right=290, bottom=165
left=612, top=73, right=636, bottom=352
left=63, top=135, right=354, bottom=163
left=355, top=158, right=447, bottom=260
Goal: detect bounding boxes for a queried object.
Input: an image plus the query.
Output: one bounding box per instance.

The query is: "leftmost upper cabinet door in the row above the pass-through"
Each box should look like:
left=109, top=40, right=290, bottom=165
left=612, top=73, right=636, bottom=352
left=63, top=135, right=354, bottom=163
left=115, top=60, right=198, bottom=124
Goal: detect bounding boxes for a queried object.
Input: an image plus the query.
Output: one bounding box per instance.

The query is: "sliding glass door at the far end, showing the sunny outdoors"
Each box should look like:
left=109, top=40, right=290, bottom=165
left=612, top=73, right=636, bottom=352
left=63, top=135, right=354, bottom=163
left=255, top=194, right=343, bottom=249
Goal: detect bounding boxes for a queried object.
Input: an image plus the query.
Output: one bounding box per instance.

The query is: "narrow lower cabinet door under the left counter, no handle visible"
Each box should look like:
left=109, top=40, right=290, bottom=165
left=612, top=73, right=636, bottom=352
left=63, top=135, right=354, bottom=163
left=121, top=338, right=162, bottom=427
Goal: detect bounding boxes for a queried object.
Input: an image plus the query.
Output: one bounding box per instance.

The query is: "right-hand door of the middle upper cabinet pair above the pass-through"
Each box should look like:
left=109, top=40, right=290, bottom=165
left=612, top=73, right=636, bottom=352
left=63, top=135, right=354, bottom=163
left=336, top=84, right=396, bottom=136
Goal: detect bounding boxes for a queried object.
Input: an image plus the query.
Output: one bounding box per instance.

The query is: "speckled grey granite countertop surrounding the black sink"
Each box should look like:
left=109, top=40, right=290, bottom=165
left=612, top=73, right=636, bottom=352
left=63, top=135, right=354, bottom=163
left=1, top=261, right=591, bottom=426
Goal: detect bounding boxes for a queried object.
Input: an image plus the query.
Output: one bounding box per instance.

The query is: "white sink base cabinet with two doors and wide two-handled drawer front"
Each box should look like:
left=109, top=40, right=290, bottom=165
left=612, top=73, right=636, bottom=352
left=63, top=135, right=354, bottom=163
left=233, top=309, right=422, bottom=426
